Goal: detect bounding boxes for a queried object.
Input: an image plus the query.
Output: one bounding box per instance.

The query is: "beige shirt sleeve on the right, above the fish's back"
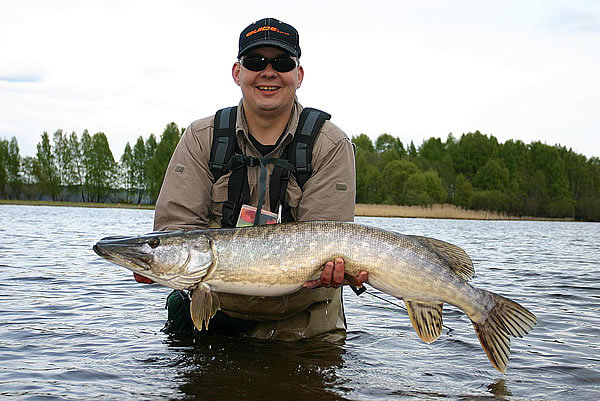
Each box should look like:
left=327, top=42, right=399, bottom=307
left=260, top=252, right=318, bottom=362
left=298, top=122, right=356, bottom=221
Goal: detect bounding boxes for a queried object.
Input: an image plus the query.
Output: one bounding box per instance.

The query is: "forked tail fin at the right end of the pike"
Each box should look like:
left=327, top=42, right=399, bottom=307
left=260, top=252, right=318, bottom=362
left=473, top=294, right=537, bottom=373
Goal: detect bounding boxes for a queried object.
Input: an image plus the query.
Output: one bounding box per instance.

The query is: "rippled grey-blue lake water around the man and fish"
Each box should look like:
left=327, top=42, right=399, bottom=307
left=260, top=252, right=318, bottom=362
left=0, top=205, right=600, bottom=401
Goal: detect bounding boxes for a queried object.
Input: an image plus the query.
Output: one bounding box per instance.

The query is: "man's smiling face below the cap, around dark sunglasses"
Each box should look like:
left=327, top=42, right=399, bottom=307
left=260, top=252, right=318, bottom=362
left=232, top=47, right=304, bottom=115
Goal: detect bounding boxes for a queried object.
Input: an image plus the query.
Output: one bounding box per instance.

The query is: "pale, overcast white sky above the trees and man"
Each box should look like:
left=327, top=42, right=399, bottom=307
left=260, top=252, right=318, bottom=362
left=0, top=0, right=600, bottom=159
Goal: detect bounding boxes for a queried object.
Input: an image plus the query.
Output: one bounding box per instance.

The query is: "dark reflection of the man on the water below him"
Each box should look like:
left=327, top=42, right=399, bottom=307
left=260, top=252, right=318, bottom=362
left=166, top=335, right=344, bottom=400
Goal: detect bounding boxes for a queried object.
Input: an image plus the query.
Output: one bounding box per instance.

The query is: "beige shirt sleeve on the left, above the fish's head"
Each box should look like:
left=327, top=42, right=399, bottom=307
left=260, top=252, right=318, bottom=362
left=154, top=123, right=212, bottom=231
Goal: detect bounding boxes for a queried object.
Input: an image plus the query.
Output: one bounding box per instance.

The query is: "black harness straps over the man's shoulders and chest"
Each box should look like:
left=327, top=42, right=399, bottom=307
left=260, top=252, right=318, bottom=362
left=209, top=107, right=331, bottom=227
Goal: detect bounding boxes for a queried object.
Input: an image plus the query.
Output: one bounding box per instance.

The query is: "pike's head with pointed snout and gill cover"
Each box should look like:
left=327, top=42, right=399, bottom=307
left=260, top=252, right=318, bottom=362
left=93, top=231, right=214, bottom=289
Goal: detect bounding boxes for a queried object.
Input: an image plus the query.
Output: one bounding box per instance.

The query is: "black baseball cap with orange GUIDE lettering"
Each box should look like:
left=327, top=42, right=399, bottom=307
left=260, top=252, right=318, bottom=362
left=238, top=18, right=300, bottom=58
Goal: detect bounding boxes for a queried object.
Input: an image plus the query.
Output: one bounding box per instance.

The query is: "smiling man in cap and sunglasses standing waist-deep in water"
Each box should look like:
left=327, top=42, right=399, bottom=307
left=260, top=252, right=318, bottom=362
left=142, top=18, right=367, bottom=341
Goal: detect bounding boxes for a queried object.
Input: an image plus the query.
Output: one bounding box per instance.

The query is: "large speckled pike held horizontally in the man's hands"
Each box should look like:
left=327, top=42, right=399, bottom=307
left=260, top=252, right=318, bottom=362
left=94, top=222, right=537, bottom=372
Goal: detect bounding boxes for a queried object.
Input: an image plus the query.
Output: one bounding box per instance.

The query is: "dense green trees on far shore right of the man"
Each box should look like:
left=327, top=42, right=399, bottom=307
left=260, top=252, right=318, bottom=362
left=352, top=131, right=600, bottom=221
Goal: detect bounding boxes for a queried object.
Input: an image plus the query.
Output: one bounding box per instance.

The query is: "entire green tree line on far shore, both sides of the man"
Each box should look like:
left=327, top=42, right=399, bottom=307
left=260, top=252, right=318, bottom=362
left=0, top=123, right=600, bottom=221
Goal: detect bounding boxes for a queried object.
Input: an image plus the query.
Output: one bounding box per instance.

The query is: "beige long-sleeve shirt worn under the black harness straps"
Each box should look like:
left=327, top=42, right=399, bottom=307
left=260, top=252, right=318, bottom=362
left=154, top=101, right=356, bottom=231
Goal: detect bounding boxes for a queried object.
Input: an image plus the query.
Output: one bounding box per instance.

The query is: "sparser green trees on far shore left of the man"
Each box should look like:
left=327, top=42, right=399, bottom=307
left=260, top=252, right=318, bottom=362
left=0, top=123, right=183, bottom=204
